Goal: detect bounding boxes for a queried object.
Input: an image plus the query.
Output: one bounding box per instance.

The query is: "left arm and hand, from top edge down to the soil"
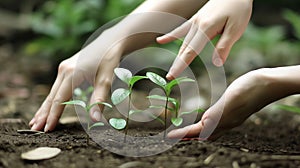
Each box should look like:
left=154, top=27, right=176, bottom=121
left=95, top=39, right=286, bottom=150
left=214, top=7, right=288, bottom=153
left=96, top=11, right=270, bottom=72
left=29, top=0, right=206, bottom=132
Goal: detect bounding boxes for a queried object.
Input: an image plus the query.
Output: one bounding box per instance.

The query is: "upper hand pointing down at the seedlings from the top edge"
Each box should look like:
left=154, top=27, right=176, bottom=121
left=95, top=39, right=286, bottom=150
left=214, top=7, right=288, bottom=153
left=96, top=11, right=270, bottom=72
left=157, top=0, right=253, bottom=80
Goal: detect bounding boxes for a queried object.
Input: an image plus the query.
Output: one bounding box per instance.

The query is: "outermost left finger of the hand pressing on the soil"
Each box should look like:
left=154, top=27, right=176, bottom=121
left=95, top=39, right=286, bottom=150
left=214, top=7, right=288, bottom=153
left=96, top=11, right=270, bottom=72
left=29, top=74, right=62, bottom=130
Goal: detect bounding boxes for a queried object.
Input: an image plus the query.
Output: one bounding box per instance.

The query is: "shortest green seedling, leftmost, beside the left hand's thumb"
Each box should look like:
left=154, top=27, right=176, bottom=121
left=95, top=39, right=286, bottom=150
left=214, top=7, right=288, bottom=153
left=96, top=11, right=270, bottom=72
left=62, top=100, right=112, bottom=144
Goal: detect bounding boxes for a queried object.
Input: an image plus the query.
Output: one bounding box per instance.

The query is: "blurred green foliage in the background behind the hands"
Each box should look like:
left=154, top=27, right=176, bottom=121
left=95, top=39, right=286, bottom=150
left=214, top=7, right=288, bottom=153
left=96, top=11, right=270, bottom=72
left=25, top=0, right=300, bottom=78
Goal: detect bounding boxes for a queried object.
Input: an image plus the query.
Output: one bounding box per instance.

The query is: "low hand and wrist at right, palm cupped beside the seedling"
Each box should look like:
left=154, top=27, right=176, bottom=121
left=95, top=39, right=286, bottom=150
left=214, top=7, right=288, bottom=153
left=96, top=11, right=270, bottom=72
left=168, top=66, right=300, bottom=140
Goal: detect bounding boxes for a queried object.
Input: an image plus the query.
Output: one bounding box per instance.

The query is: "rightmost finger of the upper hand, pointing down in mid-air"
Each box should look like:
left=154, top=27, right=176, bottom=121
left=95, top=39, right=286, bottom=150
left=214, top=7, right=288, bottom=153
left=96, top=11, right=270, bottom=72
left=212, top=25, right=237, bottom=67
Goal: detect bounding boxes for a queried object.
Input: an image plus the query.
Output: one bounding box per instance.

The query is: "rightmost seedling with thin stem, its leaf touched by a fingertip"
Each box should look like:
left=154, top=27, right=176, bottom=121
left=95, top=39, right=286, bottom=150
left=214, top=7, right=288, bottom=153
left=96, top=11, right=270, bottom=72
left=146, top=72, right=194, bottom=137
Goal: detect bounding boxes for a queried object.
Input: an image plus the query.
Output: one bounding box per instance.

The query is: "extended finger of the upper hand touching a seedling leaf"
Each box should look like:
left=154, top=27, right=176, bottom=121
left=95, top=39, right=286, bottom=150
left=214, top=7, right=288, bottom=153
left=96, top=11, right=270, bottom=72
left=167, top=29, right=209, bottom=79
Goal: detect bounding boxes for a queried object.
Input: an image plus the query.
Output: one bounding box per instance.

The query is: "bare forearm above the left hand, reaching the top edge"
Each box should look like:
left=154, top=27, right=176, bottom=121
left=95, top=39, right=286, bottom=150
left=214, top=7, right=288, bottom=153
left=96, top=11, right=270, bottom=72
left=105, top=0, right=207, bottom=53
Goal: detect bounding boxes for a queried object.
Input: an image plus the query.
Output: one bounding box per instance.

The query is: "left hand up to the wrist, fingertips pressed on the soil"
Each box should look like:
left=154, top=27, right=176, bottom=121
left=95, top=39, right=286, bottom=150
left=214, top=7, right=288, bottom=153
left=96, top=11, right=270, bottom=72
left=29, top=30, right=122, bottom=132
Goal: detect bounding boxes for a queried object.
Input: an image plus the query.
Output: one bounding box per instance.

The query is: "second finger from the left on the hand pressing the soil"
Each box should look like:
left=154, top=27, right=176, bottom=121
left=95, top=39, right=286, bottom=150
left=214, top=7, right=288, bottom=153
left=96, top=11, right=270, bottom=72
left=44, top=76, right=72, bottom=132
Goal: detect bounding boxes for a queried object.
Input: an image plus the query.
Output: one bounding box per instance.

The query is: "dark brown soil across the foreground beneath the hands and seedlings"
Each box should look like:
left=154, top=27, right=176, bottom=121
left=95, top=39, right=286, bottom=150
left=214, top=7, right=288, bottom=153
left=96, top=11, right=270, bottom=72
left=0, top=112, right=300, bottom=168
